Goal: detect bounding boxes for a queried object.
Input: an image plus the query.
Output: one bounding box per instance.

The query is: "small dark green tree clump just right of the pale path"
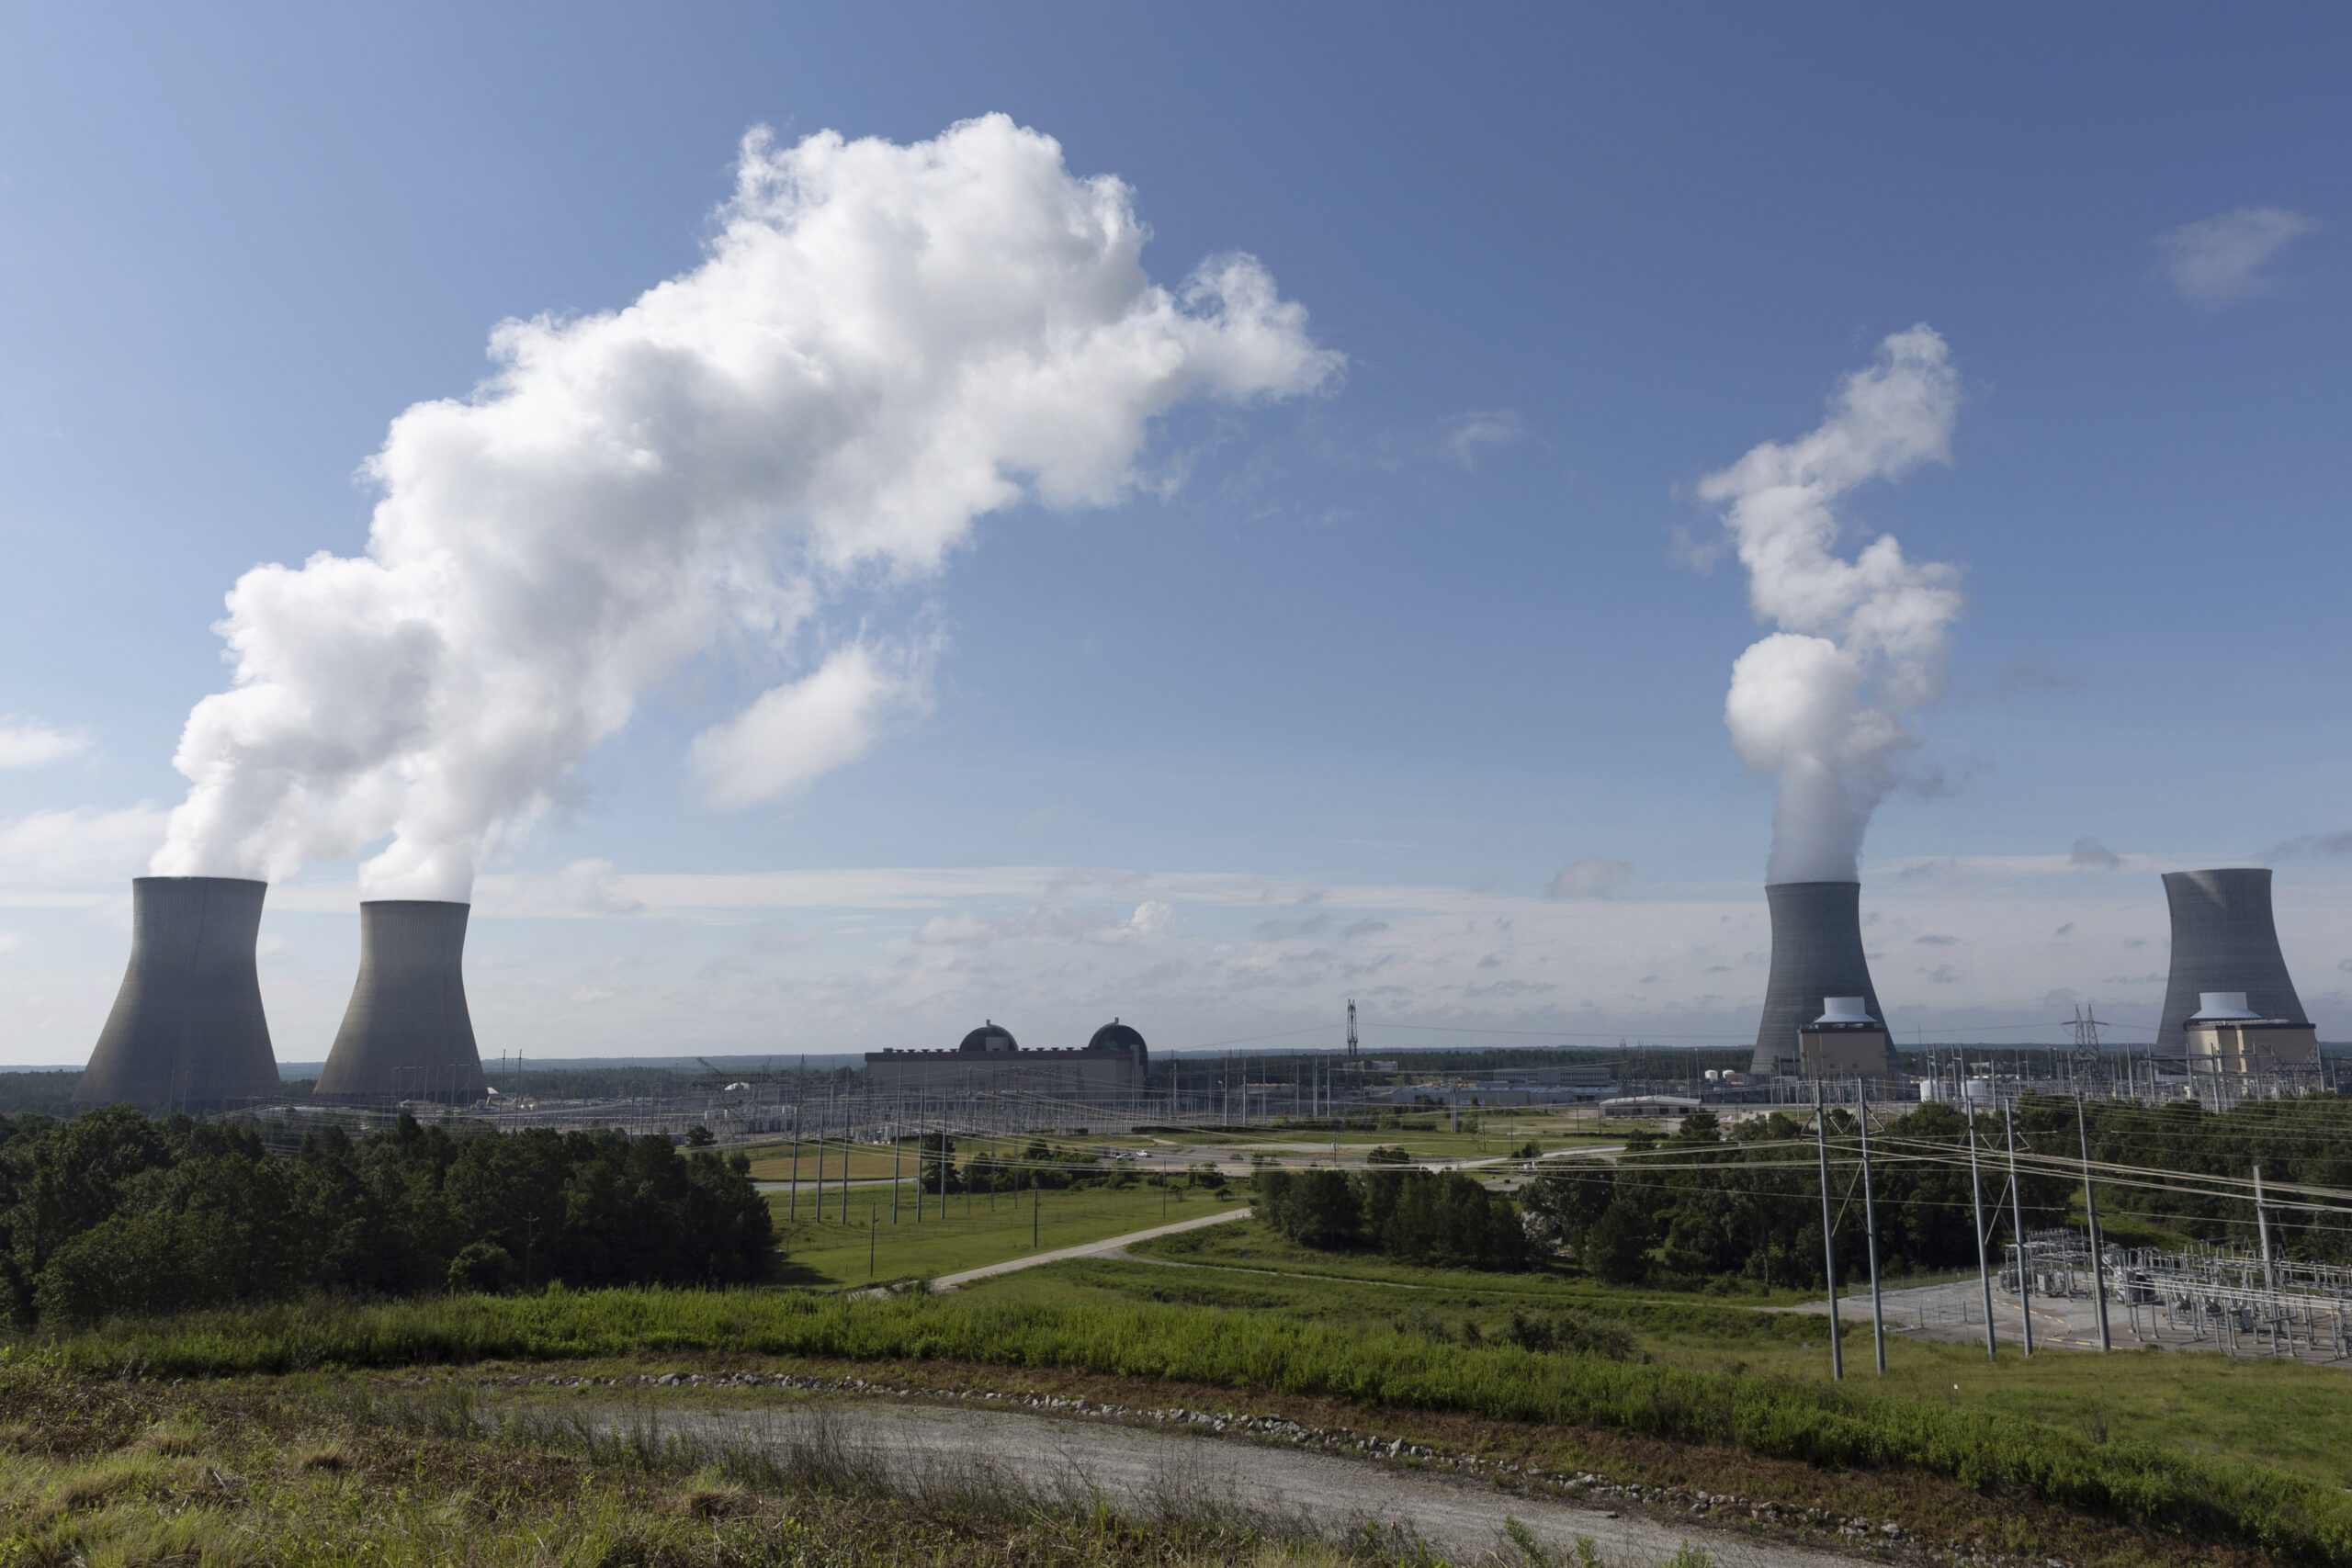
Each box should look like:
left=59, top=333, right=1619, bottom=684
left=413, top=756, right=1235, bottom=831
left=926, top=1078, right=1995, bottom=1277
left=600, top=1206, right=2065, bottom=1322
left=1251, top=1166, right=1529, bottom=1269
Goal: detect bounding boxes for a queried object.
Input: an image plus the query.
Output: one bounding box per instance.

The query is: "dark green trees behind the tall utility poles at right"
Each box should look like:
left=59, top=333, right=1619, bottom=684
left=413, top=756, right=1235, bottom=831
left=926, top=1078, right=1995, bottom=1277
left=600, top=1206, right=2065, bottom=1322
left=1521, top=1100, right=2076, bottom=1286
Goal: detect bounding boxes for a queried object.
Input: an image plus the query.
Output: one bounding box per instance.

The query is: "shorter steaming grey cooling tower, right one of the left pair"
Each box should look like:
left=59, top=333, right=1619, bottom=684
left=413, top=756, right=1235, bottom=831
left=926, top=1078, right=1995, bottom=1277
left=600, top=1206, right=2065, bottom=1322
left=311, top=898, right=489, bottom=1105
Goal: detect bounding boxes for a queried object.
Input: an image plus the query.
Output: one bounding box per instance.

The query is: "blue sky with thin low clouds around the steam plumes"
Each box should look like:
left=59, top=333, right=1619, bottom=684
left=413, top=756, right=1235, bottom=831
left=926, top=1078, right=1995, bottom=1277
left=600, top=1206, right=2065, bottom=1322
left=0, top=5, right=2352, bottom=1063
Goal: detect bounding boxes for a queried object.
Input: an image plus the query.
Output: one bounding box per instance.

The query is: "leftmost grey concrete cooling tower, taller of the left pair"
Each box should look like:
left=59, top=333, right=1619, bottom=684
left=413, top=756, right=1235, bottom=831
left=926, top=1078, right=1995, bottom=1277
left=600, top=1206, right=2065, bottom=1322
left=73, top=877, right=282, bottom=1110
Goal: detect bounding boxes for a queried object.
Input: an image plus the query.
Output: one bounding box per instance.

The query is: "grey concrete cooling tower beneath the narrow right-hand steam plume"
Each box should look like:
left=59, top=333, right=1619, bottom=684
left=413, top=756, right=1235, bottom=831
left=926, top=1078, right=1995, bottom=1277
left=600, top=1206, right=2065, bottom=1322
left=1755, top=882, right=1898, bottom=1077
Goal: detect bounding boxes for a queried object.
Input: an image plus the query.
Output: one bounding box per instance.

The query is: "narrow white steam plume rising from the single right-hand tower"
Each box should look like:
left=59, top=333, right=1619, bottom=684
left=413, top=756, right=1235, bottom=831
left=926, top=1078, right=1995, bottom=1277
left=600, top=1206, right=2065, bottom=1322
left=1698, top=327, right=1962, bottom=882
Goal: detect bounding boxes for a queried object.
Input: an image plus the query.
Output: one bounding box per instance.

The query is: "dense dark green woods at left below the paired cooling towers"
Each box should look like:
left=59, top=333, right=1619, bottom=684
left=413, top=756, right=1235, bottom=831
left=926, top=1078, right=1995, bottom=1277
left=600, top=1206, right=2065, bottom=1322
left=0, top=1105, right=774, bottom=1324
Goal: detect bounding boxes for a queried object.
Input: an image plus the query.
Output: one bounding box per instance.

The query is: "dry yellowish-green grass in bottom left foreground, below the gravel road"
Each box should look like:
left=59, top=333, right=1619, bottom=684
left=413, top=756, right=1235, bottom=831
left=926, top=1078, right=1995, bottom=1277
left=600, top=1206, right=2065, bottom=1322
left=0, top=1366, right=1425, bottom=1568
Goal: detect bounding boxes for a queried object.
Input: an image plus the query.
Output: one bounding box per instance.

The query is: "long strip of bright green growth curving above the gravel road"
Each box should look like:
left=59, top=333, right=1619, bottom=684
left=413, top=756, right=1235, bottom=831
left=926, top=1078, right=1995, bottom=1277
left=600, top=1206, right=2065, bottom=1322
left=35, top=1291, right=2352, bottom=1565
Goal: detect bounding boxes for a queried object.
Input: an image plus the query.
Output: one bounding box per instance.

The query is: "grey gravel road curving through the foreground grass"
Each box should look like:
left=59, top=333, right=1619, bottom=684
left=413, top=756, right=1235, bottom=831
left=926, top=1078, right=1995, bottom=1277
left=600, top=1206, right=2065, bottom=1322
left=635, top=1401, right=1851, bottom=1568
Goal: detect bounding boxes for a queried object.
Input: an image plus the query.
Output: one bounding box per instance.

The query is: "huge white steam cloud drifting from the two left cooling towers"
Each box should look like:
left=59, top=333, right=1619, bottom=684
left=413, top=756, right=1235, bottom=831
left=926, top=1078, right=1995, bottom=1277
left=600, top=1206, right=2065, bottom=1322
left=153, top=115, right=1340, bottom=898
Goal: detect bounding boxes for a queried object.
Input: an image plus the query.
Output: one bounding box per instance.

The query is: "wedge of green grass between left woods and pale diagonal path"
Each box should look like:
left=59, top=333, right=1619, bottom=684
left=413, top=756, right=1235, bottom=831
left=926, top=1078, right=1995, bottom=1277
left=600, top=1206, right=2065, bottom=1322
left=767, top=1185, right=1247, bottom=1291
